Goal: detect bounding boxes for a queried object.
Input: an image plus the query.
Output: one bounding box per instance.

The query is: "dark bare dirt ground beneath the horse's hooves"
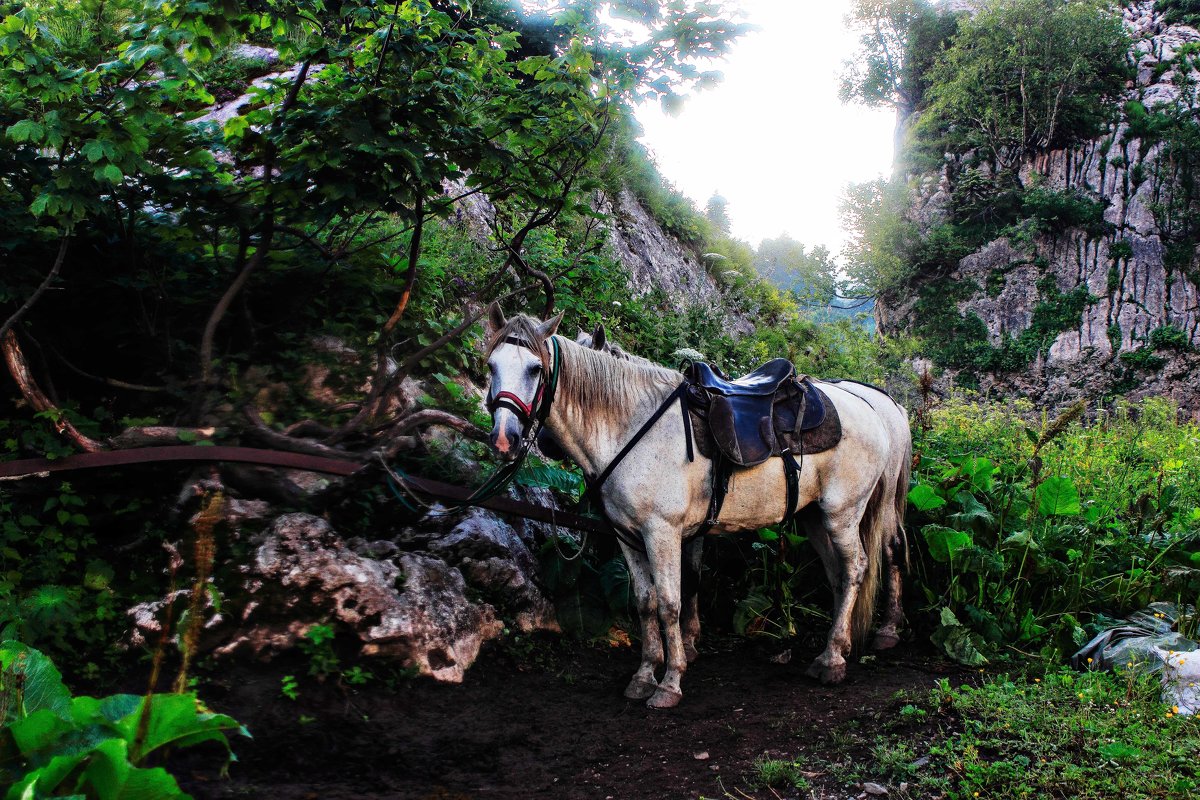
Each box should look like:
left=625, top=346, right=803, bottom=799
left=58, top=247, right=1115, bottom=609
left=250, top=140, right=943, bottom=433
left=178, top=639, right=959, bottom=800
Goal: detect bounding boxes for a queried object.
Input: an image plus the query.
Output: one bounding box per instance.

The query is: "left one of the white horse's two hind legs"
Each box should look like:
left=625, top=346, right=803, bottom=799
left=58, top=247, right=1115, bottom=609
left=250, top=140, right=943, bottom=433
left=808, top=506, right=866, bottom=684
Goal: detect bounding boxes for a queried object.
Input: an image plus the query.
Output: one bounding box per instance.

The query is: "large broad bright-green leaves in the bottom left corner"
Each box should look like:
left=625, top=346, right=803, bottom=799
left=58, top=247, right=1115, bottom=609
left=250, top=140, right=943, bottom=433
left=0, top=642, right=250, bottom=799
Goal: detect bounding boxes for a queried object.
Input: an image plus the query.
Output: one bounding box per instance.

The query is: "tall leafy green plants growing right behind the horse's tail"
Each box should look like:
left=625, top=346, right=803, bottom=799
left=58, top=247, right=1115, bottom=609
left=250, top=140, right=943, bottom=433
left=908, top=401, right=1200, bottom=663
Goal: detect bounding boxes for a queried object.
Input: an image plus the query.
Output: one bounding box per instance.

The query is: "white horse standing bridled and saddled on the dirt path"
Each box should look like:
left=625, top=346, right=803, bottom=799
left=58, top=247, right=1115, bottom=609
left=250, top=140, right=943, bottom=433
left=487, top=303, right=912, bottom=708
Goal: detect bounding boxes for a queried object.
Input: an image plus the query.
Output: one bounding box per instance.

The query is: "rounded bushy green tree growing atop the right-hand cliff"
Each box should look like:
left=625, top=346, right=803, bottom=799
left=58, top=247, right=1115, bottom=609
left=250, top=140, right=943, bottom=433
left=920, top=0, right=1129, bottom=169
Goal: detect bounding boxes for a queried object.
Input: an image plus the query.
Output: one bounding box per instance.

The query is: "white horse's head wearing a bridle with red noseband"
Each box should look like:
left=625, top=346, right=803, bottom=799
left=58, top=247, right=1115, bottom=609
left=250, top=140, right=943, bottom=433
left=487, top=302, right=563, bottom=461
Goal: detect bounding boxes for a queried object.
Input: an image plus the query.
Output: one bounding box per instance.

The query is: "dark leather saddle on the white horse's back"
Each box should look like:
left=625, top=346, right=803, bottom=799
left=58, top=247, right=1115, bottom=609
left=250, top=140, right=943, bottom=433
left=685, top=359, right=841, bottom=467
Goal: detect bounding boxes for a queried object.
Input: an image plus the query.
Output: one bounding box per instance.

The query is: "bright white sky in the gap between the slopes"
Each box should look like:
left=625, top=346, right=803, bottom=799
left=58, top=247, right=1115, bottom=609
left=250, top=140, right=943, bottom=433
left=637, top=0, right=895, bottom=255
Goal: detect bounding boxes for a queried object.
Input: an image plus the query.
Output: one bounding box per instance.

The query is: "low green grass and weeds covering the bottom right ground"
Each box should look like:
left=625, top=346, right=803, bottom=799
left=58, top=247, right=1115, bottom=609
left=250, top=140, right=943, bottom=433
left=763, top=668, right=1200, bottom=800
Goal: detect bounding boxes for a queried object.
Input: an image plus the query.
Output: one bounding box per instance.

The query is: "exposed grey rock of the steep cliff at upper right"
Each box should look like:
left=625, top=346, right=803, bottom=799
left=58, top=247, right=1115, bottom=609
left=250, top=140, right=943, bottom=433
left=880, top=1, right=1200, bottom=414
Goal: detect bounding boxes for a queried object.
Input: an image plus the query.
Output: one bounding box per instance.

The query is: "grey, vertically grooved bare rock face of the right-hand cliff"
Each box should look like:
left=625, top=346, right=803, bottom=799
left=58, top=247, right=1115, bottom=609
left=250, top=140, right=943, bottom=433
left=880, top=1, right=1200, bottom=413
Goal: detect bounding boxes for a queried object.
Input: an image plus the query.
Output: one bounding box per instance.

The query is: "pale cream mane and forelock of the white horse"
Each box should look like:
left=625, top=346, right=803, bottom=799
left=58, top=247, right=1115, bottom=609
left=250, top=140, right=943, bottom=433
left=487, top=314, right=683, bottom=428
